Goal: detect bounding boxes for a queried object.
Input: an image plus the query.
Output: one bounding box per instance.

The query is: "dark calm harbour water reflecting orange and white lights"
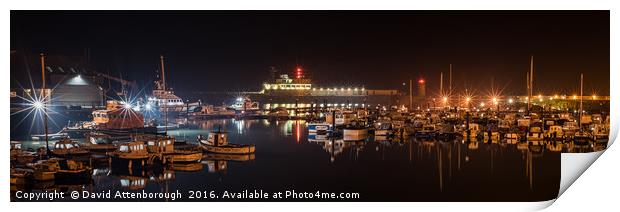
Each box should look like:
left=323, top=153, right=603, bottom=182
left=11, top=119, right=568, bottom=201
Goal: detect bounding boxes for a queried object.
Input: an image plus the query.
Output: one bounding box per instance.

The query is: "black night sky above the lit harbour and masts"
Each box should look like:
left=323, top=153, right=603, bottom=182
left=11, top=11, right=610, bottom=95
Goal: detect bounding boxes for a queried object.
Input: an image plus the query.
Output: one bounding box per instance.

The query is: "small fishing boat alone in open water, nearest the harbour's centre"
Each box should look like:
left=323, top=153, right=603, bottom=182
left=198, top=130, right=256, bottom=154
